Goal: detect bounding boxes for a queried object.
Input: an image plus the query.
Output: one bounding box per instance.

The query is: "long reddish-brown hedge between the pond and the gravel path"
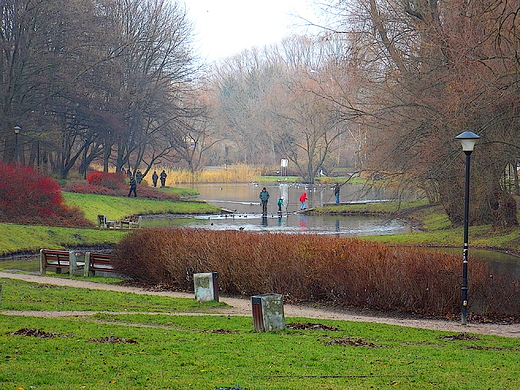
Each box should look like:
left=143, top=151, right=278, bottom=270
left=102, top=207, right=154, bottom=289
left=111, top=229, right=519, bottom=316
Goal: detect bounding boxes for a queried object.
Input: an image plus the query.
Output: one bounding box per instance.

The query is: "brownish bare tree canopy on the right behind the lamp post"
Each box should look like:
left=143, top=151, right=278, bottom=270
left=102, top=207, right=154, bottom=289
left=324, top=0, right=520, bottom=228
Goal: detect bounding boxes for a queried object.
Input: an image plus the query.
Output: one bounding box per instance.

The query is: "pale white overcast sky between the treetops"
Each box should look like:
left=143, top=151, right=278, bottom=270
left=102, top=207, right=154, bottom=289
left=185, top=0, right=313, bottom=61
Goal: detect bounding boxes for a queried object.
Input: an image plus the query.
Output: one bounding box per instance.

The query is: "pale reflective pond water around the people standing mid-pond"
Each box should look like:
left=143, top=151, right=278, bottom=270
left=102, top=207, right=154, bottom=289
left=152, top=183, right=411, bottom=237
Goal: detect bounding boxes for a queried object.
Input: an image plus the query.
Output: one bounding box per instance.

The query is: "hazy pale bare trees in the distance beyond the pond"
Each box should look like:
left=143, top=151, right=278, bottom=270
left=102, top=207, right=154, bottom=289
left=207, top=36, right=358, bottom=182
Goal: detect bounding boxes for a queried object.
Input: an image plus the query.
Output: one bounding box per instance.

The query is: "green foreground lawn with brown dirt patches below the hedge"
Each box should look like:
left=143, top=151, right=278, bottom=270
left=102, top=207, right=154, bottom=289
left=0, top=279, right=520, bottom=390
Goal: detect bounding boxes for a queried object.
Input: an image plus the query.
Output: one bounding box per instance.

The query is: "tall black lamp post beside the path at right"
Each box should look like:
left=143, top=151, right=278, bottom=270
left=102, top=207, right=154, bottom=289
left=455, top=131, right=480, bottom=325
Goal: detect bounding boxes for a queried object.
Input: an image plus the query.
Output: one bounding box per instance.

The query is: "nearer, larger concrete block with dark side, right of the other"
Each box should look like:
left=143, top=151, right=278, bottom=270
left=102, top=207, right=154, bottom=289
left=251, top=294, right=285, bottom=332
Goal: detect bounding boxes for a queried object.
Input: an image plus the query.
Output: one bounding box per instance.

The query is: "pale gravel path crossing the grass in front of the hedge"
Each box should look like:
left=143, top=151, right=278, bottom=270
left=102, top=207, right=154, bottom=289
left=0, top=272, right=520, bottom=338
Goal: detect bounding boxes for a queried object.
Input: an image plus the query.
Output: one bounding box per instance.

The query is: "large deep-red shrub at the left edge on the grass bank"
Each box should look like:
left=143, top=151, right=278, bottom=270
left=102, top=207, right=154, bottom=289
left=0, top=163, right=92, bottom=226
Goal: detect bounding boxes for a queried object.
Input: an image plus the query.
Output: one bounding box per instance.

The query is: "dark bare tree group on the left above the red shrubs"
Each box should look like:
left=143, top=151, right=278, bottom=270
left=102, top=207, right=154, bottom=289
left=0, top=0, right=203, bottom=177
